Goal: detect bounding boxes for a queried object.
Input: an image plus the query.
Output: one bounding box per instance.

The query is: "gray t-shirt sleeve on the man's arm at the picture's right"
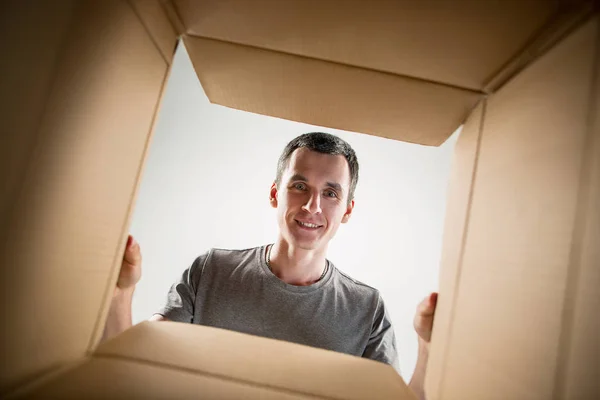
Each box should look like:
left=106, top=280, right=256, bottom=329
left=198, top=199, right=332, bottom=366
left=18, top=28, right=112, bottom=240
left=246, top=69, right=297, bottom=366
left=363, top=295, right=400, bottom=373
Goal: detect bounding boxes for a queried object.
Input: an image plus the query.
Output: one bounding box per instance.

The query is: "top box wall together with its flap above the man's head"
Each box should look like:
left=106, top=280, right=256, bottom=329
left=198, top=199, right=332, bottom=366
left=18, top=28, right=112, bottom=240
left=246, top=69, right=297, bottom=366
left=172, top=0, right=568, bottom=146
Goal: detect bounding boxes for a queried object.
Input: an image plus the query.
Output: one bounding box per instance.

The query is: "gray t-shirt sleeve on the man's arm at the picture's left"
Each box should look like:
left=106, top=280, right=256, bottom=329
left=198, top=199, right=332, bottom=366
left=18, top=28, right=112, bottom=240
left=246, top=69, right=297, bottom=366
left=156, top=254, right=207, bottom=322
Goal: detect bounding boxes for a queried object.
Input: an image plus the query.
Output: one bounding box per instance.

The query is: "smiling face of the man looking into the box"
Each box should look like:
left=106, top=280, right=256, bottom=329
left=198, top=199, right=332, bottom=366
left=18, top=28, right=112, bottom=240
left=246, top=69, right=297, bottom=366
left=271, top=148, right=354, bottom=250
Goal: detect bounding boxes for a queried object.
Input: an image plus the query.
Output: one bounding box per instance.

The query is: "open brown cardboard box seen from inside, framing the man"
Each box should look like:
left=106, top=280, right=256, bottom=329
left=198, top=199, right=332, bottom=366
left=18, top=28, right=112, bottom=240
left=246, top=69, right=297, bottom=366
left=0, top=0, right=600, bottom=399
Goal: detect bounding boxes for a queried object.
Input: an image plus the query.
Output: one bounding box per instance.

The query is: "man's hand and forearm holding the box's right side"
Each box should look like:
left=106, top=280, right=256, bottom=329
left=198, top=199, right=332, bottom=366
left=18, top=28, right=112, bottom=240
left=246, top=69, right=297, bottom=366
left=408, top=293, right=437, bottom=400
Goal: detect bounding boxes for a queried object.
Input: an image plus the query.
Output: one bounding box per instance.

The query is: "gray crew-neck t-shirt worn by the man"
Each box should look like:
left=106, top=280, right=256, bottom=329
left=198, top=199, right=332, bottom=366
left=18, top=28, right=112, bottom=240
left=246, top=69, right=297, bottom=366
left=158, top=246, right=398, bottom=370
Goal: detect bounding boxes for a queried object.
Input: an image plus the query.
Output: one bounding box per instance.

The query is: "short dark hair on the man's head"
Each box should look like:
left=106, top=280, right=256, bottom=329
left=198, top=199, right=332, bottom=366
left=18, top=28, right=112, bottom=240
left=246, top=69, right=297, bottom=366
left=275, top=132, right=358, bottom=202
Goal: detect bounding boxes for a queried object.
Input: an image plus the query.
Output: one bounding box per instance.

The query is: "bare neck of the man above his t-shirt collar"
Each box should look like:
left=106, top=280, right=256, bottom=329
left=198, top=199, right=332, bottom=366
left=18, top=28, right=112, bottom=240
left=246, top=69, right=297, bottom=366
left=270, top=238, right=327, bottom=286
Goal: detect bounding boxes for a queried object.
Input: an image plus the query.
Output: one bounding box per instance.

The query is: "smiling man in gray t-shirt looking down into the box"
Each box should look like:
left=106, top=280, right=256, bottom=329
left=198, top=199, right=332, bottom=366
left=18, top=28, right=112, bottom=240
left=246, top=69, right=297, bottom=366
left=104, top=132, right=437, bottom=398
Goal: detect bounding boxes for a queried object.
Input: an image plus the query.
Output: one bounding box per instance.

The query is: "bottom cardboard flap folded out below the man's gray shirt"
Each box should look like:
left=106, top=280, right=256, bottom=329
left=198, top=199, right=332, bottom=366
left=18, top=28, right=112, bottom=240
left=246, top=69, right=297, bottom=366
left=94, top=322, right=414, bottom=400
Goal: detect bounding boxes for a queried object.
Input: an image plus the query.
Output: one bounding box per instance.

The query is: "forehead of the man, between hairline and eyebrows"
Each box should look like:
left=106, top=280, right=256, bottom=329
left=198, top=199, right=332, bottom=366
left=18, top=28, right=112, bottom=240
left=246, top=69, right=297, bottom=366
left=284, top=147, right=350, bottom=186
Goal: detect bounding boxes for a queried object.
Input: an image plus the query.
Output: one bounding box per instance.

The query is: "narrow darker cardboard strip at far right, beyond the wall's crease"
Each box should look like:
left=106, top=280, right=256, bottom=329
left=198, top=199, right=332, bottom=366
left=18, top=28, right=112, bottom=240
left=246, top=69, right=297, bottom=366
left=555, top=21, right=600, bottom=399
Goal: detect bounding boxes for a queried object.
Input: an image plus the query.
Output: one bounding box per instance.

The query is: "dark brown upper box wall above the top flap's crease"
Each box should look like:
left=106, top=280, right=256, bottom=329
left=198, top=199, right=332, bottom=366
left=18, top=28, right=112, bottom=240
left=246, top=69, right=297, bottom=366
left=173, top=0, right=557, bottom=90
